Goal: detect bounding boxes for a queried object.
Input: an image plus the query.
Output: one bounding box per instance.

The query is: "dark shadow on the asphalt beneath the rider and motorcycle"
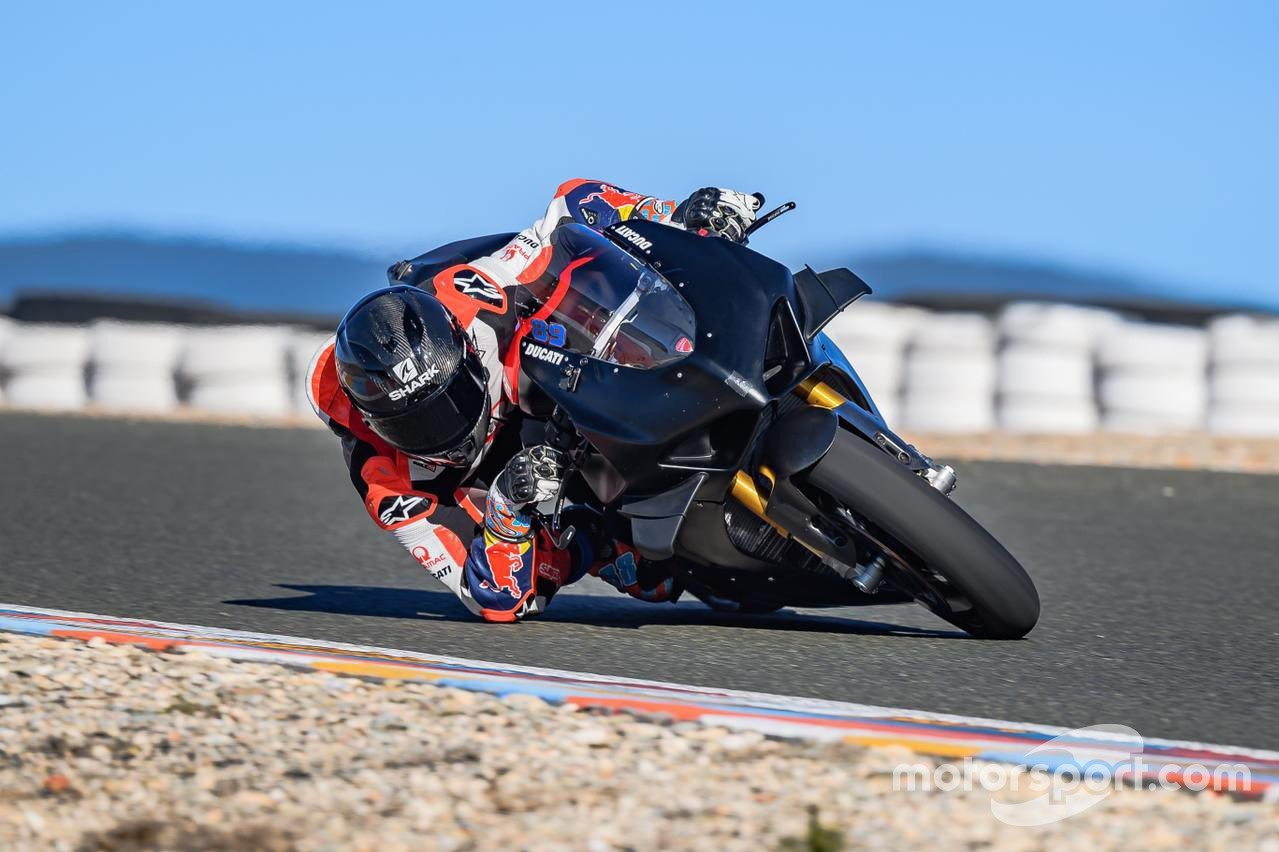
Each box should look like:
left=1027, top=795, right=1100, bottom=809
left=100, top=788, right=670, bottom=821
left=223, top=583, right=969, bottom=638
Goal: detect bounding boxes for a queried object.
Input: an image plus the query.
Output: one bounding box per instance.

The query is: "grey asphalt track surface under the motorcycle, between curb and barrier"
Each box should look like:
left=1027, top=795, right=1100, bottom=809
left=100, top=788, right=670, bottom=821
left=0, top=413, right=1279, bottom=748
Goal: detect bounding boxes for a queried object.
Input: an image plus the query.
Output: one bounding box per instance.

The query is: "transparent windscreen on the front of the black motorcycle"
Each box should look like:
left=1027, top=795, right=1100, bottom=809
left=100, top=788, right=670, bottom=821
left=533, top=224, right=697, bottom=370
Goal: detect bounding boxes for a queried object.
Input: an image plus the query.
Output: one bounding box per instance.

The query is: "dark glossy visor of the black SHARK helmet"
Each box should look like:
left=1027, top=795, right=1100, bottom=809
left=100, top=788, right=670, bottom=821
left=365, top=353, right=489, bottom=455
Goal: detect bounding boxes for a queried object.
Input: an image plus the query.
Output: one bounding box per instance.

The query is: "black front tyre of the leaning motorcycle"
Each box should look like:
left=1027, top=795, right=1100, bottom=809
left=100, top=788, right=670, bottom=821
left=807, top=430, right=1040, bottom=638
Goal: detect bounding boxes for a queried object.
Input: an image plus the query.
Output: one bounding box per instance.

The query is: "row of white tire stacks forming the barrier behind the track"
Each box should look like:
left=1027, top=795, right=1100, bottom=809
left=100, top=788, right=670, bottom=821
left=0, top=303, right=1279, bottom=436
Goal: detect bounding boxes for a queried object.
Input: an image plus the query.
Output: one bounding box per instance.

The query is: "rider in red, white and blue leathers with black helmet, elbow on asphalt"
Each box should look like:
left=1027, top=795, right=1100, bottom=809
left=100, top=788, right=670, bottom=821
left=307, top=179, right=762, bottom=622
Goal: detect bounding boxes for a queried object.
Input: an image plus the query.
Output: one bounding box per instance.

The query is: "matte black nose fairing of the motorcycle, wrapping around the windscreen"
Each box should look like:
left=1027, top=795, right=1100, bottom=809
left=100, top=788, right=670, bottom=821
left=522, top=220, right=798, bottom=490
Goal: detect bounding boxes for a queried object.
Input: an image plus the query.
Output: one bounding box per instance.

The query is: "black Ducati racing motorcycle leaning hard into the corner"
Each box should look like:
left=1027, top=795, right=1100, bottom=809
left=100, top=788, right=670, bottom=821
left=422, top=203, right=1040, bottom=638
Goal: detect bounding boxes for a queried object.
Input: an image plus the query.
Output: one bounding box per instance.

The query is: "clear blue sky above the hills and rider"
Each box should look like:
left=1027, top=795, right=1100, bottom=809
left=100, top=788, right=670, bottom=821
left=0, top=1, right=1279, bottom=301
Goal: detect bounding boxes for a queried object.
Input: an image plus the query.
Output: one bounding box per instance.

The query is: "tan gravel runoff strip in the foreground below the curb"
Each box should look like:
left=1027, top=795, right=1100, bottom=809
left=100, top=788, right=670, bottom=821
left=0, top=635, right=1279, bottom=852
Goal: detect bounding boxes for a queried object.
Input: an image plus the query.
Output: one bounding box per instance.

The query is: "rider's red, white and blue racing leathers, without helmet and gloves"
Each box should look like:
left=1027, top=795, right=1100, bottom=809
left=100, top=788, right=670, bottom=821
left=307, top=179, right=677, bottom=622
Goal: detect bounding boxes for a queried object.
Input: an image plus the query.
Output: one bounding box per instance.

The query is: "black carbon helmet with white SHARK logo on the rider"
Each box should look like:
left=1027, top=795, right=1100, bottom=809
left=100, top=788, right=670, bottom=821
left=334, top=284, right=489, bottom=467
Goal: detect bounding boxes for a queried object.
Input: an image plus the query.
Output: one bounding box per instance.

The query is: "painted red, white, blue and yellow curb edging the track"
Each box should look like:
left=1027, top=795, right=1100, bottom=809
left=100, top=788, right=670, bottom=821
left=0, top=604, right=1279, bottom=798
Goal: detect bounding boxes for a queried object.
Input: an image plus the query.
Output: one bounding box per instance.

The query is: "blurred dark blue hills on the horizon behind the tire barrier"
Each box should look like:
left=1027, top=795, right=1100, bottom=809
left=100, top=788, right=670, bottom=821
left=0, top=234, right=1279, bottom=315
